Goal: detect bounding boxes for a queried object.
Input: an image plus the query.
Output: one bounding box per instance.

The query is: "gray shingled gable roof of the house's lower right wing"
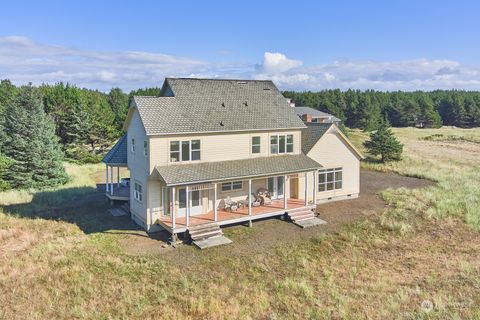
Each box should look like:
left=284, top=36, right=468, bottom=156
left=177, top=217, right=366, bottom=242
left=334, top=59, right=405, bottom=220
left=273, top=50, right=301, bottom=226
left=302, top=123, right=364, bottom=159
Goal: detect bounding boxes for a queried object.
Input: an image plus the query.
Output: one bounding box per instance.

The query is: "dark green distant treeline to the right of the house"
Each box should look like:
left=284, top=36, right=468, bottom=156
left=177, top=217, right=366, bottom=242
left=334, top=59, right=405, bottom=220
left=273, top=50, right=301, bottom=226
left=283, top=89, right=480, bottom=131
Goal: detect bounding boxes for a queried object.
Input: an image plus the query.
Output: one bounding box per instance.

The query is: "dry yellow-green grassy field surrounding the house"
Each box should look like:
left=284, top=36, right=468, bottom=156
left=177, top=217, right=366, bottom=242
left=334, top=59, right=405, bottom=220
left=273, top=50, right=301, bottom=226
left=0, top=128, right=480, bottom=319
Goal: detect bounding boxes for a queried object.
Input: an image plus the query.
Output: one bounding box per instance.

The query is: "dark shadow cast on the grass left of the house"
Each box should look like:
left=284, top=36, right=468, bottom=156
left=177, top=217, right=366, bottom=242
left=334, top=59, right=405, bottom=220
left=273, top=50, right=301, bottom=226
left=2, top=187, right=145, bottom=236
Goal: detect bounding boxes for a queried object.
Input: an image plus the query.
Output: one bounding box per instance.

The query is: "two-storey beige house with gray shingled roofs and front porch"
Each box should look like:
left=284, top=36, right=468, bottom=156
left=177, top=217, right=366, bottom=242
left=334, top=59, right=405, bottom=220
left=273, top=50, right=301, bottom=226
left=103, top=78, right=362, bottom=245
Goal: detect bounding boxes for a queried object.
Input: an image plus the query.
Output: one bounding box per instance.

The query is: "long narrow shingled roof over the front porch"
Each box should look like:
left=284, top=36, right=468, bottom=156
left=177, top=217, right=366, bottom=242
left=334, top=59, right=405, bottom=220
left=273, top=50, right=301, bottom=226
left=155, top=154, right=322, bottom=186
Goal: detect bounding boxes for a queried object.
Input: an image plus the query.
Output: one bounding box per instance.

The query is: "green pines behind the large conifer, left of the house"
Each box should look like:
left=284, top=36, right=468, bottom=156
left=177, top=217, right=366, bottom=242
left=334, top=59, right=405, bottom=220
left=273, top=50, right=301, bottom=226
left=0, top=80, right=160, bottom=163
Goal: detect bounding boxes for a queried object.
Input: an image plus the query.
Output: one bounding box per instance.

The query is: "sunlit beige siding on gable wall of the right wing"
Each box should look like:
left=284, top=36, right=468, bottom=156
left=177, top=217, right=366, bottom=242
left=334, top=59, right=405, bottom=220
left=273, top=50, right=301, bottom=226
left=299, top=128, right=360, bottom=200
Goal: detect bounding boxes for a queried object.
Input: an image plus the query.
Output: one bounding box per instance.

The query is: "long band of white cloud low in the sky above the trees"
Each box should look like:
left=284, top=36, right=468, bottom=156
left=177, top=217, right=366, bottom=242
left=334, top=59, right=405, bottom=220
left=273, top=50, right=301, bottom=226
left=0, top=36, right=480, bottom=91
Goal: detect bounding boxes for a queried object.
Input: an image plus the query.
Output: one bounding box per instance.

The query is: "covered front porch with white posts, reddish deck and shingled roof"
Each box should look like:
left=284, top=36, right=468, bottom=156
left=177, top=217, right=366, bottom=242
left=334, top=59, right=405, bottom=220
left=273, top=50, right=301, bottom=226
left=152, top=155, right=321, bottom=234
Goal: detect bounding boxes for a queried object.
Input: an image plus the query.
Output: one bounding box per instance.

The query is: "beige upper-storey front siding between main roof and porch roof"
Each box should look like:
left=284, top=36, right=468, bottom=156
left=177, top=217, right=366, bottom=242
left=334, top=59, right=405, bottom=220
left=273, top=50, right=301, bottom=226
left=150, top=130, right=301, bottom=172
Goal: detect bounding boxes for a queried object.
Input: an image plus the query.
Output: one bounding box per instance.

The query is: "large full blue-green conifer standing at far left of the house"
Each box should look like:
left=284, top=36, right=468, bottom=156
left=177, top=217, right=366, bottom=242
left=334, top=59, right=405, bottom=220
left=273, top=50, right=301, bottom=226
left=5, top=85, right=68, bottom=188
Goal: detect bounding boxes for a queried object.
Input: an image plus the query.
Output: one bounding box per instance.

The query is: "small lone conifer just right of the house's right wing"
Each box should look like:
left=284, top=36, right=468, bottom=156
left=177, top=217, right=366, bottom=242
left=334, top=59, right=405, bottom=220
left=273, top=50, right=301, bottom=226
left=363, top=120, right=403, bottom=162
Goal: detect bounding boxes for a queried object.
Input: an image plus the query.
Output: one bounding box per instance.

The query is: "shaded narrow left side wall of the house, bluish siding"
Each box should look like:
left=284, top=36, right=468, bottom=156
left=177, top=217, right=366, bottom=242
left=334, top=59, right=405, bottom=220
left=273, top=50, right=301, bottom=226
left=127, top=110, right=149, bottom=228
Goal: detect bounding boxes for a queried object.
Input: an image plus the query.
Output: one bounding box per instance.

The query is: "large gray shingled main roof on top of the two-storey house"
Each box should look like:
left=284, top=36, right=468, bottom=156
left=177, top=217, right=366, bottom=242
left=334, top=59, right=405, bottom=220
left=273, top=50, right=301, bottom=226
left=133, top=78, right=305, bottom=135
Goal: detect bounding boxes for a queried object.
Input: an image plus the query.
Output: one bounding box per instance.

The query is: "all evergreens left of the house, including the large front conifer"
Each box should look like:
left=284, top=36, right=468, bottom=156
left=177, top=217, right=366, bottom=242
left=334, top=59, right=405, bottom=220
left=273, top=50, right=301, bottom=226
left=0, top=80, right=160, bottom=190
